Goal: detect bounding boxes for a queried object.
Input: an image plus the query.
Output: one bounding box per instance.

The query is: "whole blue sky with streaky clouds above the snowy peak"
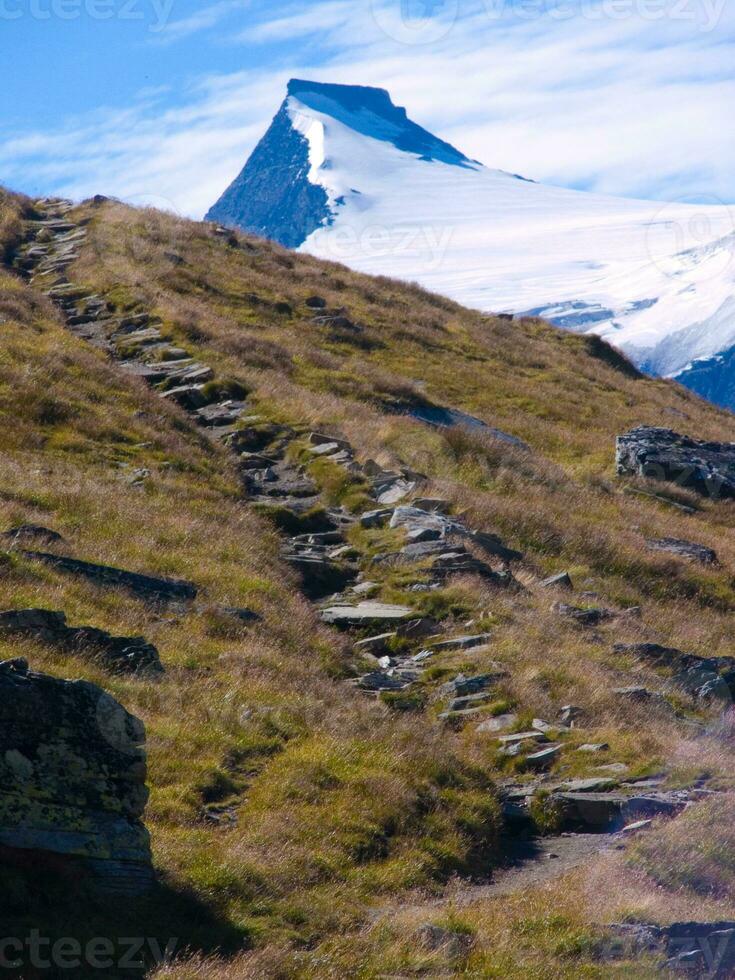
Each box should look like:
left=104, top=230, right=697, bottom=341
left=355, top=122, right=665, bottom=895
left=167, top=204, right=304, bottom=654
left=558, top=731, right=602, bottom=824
left=0, top=0, right=735, bottom=217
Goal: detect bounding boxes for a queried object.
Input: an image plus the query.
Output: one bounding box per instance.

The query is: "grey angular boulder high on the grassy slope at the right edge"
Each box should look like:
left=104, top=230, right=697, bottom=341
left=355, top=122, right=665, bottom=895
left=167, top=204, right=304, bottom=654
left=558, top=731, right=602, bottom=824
left=616, top=426, right=735, bottom=499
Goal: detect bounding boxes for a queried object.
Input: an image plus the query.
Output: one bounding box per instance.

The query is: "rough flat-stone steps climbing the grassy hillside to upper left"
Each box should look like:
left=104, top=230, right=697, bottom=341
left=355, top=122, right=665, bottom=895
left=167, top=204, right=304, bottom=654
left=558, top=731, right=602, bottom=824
left=4, top=199, right=732, bottom=948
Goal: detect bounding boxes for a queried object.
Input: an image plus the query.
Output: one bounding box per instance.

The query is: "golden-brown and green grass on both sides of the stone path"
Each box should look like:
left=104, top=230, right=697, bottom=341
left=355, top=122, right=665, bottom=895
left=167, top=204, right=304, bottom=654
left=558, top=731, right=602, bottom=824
left=0, top=189, right=735, bottom=976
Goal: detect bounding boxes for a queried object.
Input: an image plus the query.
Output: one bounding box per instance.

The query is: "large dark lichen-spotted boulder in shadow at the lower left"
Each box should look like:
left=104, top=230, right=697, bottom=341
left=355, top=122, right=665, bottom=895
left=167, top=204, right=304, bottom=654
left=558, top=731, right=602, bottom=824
left=0, top=660, right=153, bottom=894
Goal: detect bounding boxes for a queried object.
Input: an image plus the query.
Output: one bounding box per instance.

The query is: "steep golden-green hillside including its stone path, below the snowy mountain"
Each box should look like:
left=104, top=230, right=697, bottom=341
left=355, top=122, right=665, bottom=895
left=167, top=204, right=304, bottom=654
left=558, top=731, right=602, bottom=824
left=0, top=188, right=735, bottom=977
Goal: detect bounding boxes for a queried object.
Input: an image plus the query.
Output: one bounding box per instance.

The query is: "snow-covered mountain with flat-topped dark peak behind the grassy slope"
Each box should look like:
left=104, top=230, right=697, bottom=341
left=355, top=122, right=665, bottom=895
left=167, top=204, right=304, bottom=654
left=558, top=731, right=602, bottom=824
left=207, top=80, right=735, bottom=407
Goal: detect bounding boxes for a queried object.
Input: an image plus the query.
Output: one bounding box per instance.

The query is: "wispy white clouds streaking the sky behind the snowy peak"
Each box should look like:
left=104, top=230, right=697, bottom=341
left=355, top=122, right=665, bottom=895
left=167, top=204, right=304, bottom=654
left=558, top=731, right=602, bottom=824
left=0, top=0, right=735, bottom=217
